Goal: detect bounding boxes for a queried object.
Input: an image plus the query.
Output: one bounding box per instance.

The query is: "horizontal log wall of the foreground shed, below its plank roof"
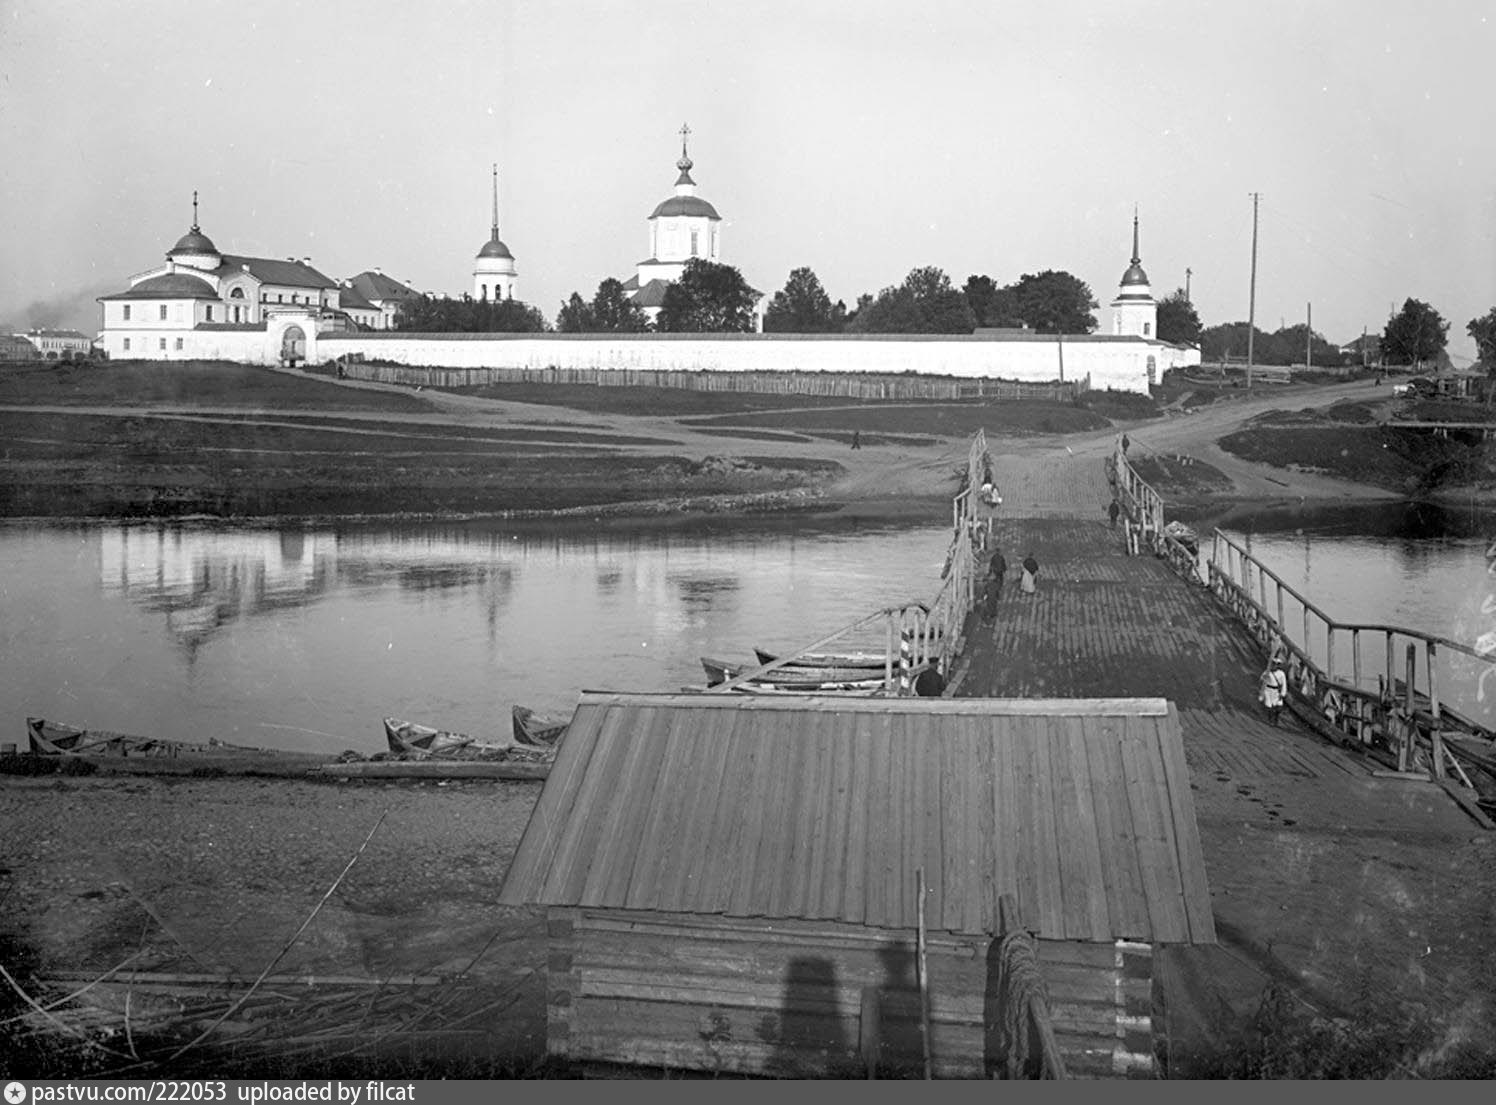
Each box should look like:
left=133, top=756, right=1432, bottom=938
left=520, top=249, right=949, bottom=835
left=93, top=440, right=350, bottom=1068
left=548, top=908, right=1153, bottom=1078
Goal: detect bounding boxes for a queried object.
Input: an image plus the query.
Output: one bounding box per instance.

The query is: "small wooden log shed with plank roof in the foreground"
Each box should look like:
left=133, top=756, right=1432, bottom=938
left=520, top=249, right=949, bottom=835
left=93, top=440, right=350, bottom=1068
left=500, top=692, right=1215, bottom=1077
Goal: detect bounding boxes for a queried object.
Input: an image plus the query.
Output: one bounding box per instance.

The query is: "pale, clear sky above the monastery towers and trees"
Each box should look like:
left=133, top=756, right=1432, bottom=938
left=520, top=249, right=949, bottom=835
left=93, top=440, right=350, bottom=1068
left=0, top=0, right=1496, bottom=363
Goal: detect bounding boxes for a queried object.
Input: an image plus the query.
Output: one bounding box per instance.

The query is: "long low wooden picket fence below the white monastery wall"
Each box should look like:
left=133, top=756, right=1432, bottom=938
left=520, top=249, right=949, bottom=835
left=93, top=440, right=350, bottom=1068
left=336, top=359, right=1089, bottom=402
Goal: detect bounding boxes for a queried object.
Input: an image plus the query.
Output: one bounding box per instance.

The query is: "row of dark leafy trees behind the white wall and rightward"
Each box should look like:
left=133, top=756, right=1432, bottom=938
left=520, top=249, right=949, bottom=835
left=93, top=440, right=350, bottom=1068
left=395, top=257, right=1496, bottom=371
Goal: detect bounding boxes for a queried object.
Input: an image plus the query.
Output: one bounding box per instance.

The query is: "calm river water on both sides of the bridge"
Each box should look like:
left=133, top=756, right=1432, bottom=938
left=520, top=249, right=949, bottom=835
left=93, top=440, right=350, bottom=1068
left=0, top=505, right=1496, bottom=754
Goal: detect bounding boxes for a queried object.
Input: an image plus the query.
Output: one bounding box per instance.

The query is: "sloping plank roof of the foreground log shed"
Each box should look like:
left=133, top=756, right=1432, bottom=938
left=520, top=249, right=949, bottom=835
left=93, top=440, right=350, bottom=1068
left=500, top=692, right=1215, bottom=942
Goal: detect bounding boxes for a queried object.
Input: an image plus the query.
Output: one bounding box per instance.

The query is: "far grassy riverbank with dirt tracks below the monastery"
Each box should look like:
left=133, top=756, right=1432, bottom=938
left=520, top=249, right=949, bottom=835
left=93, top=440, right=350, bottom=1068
left=0, top=363, right=1472, bottom=520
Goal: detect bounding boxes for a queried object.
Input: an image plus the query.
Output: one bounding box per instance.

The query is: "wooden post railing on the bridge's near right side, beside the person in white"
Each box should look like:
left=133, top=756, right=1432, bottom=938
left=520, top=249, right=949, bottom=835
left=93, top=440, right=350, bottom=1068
left=1207, top=529, right=1496, bottom=785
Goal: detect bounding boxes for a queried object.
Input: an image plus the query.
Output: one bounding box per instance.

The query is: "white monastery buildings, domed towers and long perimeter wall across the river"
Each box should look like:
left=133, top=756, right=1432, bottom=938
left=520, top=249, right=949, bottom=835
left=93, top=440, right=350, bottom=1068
left=99, top=127, right=1200, bottom=393
